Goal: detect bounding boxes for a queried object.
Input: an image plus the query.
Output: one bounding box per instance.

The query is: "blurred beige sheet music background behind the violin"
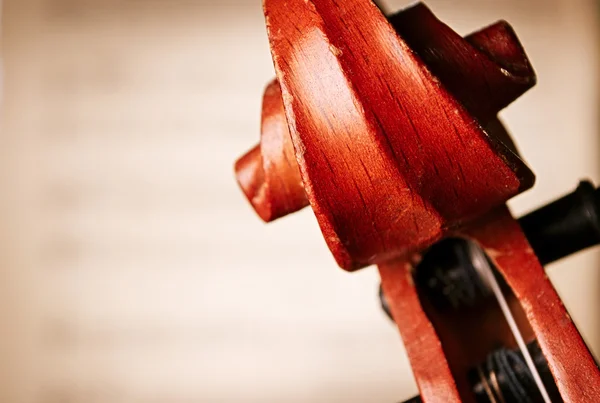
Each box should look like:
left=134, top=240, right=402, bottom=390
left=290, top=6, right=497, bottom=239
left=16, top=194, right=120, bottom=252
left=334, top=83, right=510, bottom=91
left=0, top=0, right=600, bottom=403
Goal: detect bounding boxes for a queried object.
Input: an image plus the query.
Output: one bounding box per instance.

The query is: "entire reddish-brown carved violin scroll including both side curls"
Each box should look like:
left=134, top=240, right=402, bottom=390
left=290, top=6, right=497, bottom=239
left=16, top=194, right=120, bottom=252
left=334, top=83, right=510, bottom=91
left=236, top=0, right=535, bottom=270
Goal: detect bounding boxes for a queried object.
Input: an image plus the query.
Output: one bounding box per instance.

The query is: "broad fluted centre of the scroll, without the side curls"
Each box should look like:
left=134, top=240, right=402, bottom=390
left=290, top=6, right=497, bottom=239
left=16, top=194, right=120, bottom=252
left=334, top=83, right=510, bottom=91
left=265, top=0, right=533, bottom=270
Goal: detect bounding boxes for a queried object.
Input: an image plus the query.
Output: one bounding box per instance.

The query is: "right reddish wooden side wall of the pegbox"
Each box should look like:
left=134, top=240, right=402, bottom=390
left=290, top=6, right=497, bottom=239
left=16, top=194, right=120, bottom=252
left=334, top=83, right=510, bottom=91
left=465, top=208, right=600, bottom=403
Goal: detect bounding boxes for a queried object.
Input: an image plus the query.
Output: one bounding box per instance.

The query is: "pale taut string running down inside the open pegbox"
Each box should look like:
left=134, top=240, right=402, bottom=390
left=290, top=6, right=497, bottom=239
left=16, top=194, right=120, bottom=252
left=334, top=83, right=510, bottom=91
left=469, top=243, right=552, bottom=403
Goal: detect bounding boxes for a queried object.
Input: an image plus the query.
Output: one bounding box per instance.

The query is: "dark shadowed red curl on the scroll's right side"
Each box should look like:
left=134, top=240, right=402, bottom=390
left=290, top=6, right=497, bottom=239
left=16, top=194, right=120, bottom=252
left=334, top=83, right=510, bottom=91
left=390, top=4, right=535, bottom=124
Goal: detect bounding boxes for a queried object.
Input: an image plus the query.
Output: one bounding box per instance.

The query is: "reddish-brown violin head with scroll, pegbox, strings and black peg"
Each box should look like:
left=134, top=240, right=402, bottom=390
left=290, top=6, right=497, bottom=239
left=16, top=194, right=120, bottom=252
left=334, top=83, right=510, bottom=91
left=235, top=0, right=600, bottom=403
